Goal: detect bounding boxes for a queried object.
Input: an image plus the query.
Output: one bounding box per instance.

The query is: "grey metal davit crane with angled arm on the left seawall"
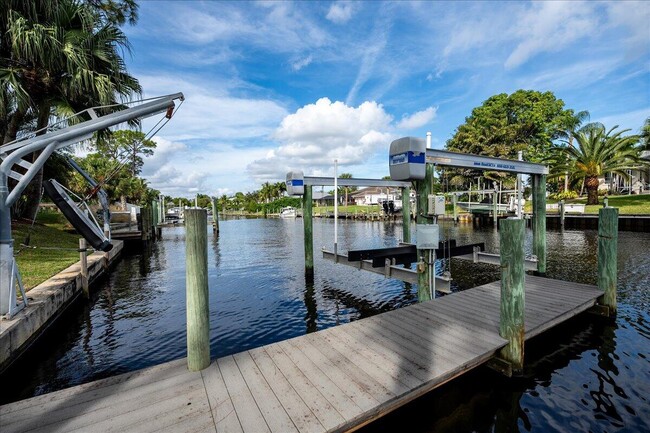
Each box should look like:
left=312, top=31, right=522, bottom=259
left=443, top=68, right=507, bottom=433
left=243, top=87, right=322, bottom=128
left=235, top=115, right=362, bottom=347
left=0, top=93, right=184, bottom=317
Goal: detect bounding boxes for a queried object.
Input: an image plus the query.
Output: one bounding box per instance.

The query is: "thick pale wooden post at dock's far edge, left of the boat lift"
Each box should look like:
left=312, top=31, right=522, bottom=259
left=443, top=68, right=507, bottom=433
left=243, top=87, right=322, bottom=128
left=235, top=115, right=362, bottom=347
left=185, top=209, right=210, bottom=371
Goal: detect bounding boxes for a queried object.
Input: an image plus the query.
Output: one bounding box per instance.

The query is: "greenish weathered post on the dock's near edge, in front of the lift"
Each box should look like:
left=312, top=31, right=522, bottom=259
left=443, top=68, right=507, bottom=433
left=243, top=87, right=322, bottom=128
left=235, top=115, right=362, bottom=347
left=499, top=218, right=526, bottom=372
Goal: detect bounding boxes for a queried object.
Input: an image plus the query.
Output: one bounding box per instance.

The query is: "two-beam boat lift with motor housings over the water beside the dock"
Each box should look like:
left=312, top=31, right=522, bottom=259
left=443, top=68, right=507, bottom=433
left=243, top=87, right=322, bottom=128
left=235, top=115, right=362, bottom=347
left=287, top=137, right=548, bottom=300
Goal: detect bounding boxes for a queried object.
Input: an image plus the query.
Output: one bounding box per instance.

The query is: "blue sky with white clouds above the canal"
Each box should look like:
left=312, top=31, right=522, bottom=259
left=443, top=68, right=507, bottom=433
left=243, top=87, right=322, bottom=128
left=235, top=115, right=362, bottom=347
left=124, top=0, right=650, bottom=197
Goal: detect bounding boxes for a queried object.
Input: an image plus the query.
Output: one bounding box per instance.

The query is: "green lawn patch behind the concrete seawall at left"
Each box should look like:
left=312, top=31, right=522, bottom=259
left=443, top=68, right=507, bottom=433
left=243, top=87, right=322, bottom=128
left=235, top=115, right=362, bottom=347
left=11, top=211, right=79, bottom=290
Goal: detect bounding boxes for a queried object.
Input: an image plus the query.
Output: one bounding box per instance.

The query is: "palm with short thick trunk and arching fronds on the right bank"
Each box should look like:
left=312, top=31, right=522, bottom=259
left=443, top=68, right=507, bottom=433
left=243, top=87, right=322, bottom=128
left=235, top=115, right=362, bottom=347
left=549, top=123, right=647, bottom=204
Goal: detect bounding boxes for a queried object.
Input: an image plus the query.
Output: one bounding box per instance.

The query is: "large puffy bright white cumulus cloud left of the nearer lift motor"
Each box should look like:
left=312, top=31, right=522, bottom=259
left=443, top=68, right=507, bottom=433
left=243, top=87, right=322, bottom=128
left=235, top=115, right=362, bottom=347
left=247, top=98, right=395, bottom=182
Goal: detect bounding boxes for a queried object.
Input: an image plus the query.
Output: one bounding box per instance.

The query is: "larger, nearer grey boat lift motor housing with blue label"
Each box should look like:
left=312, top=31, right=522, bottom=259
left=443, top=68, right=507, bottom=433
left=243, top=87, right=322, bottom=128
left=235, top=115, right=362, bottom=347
left=388, top=137, right=427, bottom=180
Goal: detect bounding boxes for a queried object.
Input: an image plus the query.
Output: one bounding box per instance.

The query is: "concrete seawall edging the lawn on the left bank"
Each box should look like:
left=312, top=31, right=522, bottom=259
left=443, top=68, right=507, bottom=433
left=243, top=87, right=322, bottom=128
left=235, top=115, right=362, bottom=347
left=0, top=241, right=124, bottom=372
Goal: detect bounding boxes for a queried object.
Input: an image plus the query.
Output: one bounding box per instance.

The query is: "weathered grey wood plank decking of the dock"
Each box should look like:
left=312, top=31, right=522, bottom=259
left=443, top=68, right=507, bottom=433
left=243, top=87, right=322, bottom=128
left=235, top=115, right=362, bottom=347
left=0, top=276, right=602, bottom=433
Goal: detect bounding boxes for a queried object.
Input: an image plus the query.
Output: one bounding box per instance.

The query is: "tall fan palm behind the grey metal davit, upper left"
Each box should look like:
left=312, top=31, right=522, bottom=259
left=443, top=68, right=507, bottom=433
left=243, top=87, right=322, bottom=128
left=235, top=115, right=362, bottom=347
left=0, top=0, right=141, bottom=218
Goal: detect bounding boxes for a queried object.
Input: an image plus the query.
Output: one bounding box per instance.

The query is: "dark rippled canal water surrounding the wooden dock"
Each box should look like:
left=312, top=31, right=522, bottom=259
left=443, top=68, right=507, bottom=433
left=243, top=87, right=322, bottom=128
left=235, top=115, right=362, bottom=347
left=0, top=219, right=650, bottom=432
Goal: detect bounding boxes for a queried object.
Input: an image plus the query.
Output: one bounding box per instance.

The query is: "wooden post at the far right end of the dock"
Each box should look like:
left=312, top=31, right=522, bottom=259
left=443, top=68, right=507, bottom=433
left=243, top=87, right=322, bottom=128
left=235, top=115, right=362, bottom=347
left=598, top=207, right=618, bottom=316
